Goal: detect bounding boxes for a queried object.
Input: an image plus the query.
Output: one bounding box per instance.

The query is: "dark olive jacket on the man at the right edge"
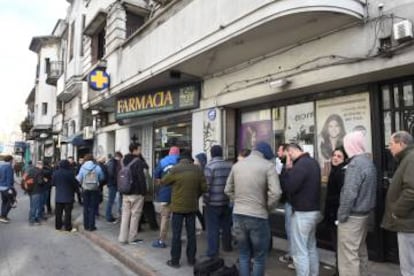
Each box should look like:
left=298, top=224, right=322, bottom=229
left=382, top=146, right=414, bottom=233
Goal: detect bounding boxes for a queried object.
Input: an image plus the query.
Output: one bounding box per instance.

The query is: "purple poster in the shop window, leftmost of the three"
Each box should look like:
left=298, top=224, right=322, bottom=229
left=239, top=110, right=272, bottom=149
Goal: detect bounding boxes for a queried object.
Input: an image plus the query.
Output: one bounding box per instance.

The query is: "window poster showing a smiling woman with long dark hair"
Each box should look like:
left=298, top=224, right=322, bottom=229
left=316, top=93, right=372, bottom=182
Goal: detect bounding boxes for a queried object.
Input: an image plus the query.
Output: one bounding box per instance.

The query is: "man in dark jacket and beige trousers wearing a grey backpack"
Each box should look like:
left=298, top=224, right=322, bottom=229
left=118, top=143, right=147, bottom=244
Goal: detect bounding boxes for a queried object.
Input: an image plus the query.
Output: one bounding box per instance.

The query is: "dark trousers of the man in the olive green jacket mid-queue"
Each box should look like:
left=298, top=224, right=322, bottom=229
left=171, top=212, right=197, bottom=264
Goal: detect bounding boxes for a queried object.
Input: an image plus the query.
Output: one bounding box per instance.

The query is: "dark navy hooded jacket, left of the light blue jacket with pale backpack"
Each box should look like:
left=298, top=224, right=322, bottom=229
left=52, top=160, right=79, bottom=203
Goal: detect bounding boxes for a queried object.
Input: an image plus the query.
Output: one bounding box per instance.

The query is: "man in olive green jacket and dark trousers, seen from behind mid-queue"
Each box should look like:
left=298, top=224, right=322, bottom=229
left=161, top=153, right=207, bottom=268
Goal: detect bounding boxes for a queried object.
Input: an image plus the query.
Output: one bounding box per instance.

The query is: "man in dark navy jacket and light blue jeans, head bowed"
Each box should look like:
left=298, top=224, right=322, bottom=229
left=284, top=143, right=321, bottom=276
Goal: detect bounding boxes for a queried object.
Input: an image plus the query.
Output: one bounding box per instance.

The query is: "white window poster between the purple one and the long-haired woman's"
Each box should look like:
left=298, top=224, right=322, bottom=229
left=285, top=102, right=315, bottom=151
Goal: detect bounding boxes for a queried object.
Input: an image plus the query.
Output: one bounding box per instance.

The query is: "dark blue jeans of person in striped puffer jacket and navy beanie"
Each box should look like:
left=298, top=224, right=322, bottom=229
left=206, top=205, right=231, bottom=257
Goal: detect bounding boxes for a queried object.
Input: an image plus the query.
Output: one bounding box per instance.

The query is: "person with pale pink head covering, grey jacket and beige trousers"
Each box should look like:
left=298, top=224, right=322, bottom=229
left=338, top=131, right=377, bottom=275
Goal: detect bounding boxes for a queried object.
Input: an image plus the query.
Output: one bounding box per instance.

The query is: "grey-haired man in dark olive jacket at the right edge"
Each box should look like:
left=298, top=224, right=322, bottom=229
left=382, top=131, right=414, bottom=276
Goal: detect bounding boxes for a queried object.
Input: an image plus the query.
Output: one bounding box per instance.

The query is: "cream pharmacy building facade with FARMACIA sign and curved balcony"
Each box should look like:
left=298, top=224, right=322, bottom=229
left=24, top=0, right=414, bottom=260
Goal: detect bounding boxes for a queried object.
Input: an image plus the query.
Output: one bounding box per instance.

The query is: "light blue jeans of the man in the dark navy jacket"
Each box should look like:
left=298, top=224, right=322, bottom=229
left=290, top=211, right=321, bottom=276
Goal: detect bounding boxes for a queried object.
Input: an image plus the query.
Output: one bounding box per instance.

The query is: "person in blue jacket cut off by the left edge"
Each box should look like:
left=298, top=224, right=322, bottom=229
left=0, top=155, right=14, bottom=223
